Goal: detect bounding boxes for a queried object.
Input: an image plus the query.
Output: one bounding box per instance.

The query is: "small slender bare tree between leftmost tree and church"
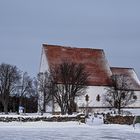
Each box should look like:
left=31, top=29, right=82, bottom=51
left=16, top=72, right=33, bottom=106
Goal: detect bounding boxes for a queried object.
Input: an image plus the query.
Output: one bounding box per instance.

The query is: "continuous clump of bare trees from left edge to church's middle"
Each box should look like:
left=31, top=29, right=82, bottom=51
left=0, top=61, right=89, bottom=114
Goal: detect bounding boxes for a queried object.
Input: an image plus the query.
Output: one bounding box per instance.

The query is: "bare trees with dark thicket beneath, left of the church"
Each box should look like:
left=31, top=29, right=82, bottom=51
left=0, top=63, right=38, bottom=114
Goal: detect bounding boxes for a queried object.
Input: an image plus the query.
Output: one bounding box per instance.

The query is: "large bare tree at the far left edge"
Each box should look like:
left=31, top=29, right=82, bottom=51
left=0, top=63, right=20, bottom=114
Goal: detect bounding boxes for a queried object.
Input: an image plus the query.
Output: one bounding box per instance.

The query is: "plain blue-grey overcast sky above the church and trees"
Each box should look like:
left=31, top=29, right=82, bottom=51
left=0, top=0, right=140, bottom=77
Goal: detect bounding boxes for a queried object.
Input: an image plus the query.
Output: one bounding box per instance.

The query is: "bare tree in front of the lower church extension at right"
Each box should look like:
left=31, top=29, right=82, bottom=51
left=105, top=75, right=137, bottom=114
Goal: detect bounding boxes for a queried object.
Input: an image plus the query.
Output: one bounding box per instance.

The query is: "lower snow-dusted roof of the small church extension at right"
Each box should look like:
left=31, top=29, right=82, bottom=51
left=110, top=67, right=140, bottom=90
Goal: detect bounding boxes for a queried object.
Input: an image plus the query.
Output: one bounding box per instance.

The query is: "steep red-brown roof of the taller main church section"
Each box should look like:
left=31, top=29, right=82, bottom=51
left=43, top=44, right=112, bottom=86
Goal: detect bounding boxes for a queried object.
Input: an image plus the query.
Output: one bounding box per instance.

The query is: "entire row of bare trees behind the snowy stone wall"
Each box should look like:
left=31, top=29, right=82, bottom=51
left=0, top=61, right=137, bottom=114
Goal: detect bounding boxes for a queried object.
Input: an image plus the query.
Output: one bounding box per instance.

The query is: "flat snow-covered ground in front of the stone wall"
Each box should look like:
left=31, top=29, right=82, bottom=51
left=0, top=118, right=140, bottom=140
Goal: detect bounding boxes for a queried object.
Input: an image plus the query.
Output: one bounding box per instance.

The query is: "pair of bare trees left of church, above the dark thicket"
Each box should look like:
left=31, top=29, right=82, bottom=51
left=0, top=63, right=35, bottom=114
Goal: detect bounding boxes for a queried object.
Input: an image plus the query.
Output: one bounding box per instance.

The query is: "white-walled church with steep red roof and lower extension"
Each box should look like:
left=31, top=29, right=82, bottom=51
left=39, top=44, right=140, bottom=112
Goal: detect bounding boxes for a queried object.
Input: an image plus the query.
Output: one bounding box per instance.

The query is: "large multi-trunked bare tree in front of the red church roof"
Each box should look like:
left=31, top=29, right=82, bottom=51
left=51, top=61, right=89, bottom=114
